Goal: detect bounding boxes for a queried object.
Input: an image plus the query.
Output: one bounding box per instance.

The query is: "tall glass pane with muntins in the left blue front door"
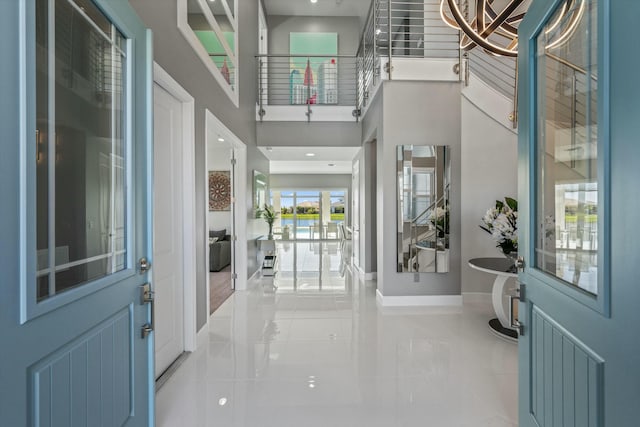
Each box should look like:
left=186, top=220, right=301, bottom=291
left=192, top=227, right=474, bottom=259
left=35, top=0, right=127, bottom=301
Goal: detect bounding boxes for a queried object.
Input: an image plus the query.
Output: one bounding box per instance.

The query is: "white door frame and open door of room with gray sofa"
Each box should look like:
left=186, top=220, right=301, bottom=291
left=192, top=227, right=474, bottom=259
left=203, top=108, right=248, bottom=304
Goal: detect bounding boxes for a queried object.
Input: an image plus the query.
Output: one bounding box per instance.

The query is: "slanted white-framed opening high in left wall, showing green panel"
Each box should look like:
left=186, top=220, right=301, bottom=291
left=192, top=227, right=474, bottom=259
left=187, top=0, right=236, bottom=90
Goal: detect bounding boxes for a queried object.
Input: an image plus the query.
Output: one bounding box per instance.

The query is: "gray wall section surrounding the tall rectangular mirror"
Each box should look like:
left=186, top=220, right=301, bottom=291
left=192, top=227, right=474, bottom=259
left=377, top=81, right=461, bottom=296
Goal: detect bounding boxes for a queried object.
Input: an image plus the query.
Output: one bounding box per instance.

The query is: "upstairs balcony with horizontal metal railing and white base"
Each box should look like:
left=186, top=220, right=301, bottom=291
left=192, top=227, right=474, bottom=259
left=256, top=0, right=462, bottom=122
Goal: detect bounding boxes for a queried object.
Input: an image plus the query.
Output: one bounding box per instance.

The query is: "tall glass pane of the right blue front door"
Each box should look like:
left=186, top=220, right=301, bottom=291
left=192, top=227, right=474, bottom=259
left=535, top=0, right=603, bottom=294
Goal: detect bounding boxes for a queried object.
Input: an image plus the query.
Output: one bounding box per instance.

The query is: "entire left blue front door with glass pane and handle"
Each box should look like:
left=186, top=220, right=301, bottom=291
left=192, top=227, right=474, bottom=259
left=0, top=0, right=154, bottom=427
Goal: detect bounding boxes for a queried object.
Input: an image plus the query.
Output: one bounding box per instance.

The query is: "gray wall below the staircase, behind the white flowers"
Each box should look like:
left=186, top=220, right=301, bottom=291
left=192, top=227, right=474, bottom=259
left=461, top=97, right=518, bottom=292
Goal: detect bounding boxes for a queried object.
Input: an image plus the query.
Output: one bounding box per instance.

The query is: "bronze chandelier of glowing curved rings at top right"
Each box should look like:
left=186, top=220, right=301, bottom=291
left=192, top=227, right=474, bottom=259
left=440, top=0, right=585, bottom=57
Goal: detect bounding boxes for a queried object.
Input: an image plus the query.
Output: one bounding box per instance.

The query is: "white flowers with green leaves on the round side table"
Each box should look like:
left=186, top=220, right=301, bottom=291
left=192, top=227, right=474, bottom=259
left=480, top=197, right=518, bottom=263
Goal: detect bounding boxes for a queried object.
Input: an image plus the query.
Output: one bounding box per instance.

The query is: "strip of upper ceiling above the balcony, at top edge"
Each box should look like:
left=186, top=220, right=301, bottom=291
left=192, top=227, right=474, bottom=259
left=264, top=0, right=371, bottom=18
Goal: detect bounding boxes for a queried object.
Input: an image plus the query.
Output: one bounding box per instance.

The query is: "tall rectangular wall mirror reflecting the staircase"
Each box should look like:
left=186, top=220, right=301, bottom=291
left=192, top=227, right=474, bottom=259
left=397, top=145, right=451, bottom=273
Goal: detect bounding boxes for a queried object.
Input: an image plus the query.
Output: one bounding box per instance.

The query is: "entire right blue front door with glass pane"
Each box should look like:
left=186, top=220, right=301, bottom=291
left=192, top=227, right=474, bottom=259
left=518, top=0, right=640, bottom=427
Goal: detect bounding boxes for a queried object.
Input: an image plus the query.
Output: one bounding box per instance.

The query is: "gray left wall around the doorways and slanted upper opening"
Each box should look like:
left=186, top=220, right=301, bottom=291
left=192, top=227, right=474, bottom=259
left=131, top=0, right=269, bottom=329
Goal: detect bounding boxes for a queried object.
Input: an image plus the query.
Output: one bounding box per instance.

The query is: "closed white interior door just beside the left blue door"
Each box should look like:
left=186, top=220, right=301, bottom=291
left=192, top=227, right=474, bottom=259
left=153, top=83, right=185, bottom=378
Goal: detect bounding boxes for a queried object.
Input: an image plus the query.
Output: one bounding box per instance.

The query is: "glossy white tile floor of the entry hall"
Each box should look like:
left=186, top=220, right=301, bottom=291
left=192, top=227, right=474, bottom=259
left=157, top=242, right=517, bottom=427
